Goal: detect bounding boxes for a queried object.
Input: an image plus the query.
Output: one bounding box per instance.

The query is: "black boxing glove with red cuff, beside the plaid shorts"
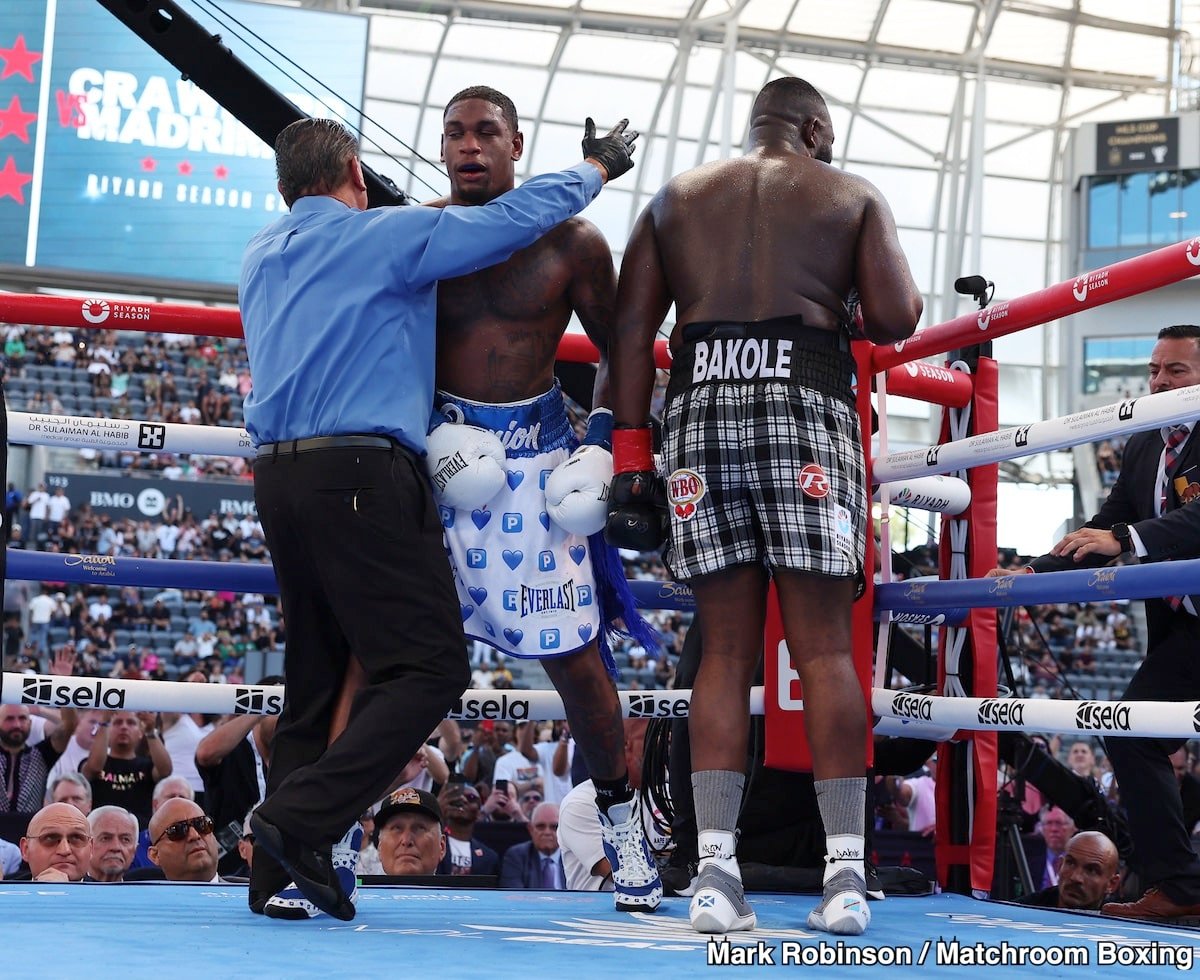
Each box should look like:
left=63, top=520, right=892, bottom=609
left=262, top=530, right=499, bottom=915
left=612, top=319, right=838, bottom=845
left=604, top=426, right=670, bottom=552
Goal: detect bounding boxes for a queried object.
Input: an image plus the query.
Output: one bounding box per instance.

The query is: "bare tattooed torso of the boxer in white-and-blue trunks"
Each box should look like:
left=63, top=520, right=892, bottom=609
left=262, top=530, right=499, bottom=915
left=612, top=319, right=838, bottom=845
left=437, top=218, right=616, bottom=402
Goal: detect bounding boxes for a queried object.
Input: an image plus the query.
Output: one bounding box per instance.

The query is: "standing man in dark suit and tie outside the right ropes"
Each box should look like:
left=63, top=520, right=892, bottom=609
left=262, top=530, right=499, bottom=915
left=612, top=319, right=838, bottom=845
left=989, top=324, right=1200, bottom=919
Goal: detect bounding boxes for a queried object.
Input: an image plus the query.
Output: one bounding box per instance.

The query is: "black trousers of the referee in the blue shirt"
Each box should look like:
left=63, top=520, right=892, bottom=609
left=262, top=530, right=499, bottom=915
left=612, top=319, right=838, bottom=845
left=254, top=446, right=470, bottom=863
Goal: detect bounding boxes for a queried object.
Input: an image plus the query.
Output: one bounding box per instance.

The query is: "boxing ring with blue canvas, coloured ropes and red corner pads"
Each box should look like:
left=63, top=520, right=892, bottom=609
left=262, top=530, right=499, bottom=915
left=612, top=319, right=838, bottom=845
left=0, top=239, right=1200, bottom=976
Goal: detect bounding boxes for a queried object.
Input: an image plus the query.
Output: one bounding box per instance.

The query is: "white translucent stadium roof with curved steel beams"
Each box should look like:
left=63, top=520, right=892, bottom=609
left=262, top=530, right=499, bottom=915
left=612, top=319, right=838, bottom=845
left=285, top=0, right=1200, bottom=321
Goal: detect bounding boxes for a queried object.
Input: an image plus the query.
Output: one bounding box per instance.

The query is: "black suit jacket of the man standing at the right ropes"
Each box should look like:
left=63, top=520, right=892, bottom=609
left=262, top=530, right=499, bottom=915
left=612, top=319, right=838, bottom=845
left=1030, top=423, right=1200, bottom=644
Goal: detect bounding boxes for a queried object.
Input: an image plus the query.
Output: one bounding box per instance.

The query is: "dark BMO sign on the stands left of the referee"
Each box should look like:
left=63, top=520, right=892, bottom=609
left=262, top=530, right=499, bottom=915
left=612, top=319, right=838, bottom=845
left=46, top=473, right=258, bottom=523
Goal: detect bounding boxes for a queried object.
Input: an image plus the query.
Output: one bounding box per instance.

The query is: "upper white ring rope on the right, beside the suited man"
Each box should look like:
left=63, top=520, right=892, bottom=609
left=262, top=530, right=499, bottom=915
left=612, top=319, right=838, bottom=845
left=874, top=385, right=1200, bottom=481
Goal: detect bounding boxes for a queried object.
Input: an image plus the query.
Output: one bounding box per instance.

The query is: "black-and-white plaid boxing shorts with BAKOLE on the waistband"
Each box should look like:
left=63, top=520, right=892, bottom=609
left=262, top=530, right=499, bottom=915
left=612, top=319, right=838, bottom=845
left=662, top=318, right=866, bottom=579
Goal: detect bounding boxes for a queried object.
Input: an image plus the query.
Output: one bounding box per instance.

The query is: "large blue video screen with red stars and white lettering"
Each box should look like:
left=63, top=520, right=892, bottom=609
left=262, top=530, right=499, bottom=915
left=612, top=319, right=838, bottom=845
left=0, top=0, right=368, bottom=285
